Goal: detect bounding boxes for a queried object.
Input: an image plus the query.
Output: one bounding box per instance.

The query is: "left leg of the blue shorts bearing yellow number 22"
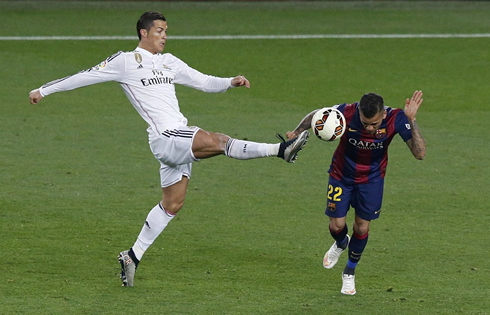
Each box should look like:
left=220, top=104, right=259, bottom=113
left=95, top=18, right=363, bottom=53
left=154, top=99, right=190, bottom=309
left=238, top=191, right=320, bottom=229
left=325, top=176, right=353, bottom=218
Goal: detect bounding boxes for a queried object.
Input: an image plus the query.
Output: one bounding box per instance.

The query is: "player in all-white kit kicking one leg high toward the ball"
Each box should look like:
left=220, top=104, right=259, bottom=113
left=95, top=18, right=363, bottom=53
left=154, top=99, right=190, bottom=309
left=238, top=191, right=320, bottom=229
left=29, top=11, right=308, bottom=286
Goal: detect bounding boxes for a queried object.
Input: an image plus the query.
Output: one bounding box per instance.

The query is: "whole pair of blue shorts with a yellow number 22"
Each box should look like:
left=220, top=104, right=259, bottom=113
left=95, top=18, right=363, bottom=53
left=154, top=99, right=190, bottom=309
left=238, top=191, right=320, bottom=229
left=325, top=176, right=384, bottom=221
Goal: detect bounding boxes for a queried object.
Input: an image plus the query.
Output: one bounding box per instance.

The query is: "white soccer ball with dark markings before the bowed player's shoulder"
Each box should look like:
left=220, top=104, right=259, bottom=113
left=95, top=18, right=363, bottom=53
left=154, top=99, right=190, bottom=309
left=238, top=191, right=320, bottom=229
left=311, top=107, right=345, bottom=141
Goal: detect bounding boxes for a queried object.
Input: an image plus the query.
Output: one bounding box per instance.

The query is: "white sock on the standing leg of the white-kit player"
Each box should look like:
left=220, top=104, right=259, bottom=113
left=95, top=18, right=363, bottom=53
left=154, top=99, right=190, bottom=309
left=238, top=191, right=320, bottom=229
left=133, top=203, right=175, bottom=260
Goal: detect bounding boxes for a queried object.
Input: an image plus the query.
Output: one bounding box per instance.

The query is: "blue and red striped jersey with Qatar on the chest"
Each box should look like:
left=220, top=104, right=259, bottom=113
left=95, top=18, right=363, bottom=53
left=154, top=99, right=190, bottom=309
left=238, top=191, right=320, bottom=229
left=328, top=102, right=412, bottom=184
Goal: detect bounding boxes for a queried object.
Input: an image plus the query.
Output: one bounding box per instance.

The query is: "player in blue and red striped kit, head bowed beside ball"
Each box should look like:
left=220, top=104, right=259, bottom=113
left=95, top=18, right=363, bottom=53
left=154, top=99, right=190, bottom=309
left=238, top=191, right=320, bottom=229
left=287, top=91, right=425, bottom=295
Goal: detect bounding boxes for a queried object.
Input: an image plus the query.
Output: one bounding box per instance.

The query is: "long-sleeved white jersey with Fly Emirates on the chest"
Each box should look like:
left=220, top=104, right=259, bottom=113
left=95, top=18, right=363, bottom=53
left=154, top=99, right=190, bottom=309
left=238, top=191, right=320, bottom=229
left=39, top=47, right=233, bottom=140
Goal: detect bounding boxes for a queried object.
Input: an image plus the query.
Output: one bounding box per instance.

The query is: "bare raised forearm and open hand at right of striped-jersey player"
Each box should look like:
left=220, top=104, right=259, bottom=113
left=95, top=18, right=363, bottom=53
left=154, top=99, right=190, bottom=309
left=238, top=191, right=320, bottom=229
left=404, top=91, right=426, bottom=160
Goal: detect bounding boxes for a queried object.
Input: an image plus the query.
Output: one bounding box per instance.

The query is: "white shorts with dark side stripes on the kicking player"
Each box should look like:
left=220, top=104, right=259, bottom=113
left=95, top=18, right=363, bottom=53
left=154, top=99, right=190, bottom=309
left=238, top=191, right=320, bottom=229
left=150, top=126, right=199, bottom=188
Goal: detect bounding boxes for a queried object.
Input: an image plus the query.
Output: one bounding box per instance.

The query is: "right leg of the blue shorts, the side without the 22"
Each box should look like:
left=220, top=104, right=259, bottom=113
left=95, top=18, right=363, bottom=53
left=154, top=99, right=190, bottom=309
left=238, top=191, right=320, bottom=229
left=352, top=180, right=384, bottom=221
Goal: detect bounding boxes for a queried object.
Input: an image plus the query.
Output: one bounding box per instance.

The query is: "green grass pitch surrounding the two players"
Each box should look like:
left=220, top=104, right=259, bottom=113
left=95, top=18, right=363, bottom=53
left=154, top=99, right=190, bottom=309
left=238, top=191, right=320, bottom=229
left=0, top=1, right=490, bottom=314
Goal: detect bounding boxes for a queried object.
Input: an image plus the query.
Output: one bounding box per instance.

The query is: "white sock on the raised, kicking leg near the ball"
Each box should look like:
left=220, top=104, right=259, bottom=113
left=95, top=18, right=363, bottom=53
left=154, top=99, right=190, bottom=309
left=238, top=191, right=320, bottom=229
left=225, top=138, right=279, bottom=160
